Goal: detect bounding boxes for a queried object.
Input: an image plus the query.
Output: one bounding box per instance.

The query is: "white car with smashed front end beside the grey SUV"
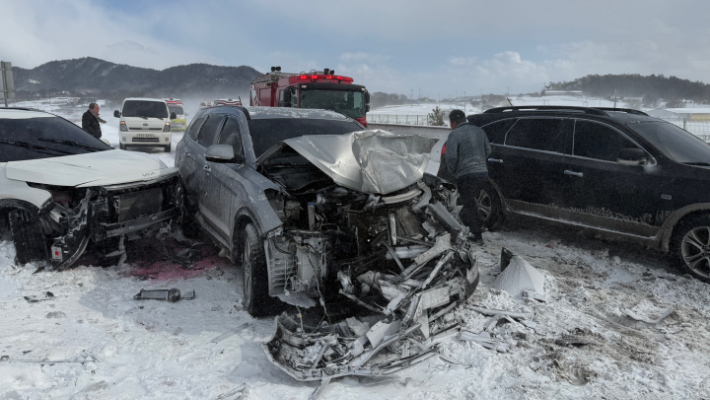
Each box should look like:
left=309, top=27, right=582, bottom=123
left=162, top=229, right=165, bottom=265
left=0, top=108, right=182, bottom=270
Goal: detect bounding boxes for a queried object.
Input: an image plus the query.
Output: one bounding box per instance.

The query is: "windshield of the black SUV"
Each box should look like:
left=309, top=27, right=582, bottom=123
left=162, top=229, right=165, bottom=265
left=629, top=121, right=710, bottom=165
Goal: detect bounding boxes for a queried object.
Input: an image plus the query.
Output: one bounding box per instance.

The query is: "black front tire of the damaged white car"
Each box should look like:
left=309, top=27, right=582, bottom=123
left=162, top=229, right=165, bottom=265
left=8, top=210, right=49, bottom=265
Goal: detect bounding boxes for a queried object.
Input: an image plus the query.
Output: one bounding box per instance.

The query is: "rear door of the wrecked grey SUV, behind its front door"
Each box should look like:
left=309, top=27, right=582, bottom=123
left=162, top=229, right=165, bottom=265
left=195, top=114, right=226, bottom=228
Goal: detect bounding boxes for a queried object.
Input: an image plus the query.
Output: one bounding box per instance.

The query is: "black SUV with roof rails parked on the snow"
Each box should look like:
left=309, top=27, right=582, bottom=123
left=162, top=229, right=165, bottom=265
left=468, top=106, right=710, bottom=281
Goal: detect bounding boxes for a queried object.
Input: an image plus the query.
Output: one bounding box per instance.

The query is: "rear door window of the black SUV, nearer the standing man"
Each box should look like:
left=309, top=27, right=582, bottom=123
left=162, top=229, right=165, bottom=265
left=505, top=118, right=566, bottom=153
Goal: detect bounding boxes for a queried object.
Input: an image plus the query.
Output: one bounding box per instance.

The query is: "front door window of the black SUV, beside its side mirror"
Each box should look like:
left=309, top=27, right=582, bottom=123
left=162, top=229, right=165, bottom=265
left=573, top=120, right=638, bottom=161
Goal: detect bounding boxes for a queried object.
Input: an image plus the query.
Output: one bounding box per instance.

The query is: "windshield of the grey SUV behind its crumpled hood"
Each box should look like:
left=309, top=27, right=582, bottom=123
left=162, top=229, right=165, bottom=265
left=249, top=118, right=363, bottom=157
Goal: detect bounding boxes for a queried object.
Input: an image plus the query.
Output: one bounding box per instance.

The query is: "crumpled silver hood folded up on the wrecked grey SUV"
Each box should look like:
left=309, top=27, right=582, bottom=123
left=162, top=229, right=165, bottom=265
left=284, top=129, right=439, bottom=194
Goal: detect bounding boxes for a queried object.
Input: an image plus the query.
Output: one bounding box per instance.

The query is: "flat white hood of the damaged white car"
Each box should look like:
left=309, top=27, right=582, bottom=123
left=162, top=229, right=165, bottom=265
left=5, top=150, right=178, bottom=187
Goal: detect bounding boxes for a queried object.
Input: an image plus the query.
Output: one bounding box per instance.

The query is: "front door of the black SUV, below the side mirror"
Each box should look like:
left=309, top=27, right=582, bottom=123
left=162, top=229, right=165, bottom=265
left=565, top=119, right=670, bottom=237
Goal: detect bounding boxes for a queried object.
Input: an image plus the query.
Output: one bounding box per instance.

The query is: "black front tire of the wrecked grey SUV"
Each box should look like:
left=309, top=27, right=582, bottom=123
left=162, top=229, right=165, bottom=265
left=242, top=223, right=277, bottom=317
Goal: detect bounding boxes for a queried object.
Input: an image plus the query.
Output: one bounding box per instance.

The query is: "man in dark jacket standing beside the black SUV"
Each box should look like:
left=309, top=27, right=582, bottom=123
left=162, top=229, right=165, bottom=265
left=442, top=110, right=491, bottom=245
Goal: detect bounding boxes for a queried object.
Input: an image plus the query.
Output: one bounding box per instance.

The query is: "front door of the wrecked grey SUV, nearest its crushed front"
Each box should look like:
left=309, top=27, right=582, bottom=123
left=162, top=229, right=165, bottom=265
left=205, top=115, right=250, bottom=242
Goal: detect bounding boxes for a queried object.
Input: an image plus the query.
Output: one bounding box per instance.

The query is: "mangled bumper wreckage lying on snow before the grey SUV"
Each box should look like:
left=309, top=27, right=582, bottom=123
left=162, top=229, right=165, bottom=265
left=262, top=245, right=479, bottom=382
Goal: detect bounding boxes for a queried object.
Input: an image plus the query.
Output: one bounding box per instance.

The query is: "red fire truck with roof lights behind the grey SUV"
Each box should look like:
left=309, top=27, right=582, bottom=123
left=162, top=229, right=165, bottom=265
left=249, top=67, right=370, bottom=126
